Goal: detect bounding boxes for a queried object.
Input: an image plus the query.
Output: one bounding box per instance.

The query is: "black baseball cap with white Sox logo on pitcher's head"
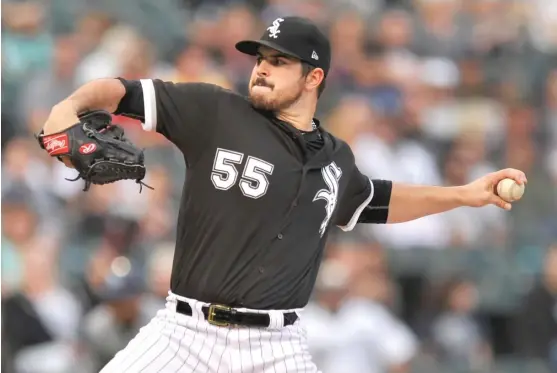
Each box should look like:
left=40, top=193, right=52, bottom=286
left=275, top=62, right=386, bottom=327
left=236, top=17, right=331, bottom=76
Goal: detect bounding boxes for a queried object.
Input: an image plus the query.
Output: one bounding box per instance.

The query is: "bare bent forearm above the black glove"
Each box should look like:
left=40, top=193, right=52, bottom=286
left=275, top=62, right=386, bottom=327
left=43, top=79, right=126, bottom=134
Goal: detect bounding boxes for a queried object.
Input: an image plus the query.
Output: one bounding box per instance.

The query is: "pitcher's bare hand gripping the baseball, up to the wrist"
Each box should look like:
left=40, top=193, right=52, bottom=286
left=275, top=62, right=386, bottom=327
left=462, top=168, right=527, bottom=210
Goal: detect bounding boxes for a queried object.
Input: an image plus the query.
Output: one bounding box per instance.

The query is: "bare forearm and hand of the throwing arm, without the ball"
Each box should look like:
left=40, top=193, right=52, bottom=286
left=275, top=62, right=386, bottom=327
left=387, top=168, right=527, bottom=223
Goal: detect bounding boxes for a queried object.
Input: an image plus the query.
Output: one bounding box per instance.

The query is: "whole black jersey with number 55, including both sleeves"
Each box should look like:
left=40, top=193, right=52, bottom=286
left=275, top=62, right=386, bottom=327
left=116, top=80, right=382, bottom=309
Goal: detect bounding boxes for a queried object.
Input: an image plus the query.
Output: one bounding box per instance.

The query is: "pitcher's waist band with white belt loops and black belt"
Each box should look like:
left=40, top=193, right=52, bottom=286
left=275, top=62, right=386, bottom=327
left=166, top=291, right=303, bottom=329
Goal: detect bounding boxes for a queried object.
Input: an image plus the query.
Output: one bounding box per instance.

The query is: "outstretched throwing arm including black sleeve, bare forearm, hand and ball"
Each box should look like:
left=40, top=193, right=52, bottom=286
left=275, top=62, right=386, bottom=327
left=336, top=159, right=527, bottom=227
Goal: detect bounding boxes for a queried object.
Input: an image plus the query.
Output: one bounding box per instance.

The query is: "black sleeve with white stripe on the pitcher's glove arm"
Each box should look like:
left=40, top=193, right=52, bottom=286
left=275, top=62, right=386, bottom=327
left=115, top=79, right=225, bottom=162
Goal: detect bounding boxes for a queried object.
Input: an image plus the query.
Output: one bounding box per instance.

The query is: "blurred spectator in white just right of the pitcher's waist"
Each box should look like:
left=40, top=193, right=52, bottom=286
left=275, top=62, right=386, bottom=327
left=306, top=245, right=417, bottom=373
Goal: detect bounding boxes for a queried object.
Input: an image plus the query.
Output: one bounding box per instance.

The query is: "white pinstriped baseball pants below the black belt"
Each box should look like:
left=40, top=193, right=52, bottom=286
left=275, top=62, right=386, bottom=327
left=100, top=292, right=318, bottom=373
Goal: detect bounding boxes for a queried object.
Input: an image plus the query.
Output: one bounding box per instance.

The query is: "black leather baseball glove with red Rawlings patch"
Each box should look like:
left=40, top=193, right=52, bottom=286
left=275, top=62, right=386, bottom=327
left=37, top=110, right=152, bottom=193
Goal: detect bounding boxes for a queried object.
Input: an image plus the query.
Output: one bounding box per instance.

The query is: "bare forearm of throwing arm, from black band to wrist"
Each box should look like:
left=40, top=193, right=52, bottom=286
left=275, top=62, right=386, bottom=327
left=387, top=183, right=464, bottom=223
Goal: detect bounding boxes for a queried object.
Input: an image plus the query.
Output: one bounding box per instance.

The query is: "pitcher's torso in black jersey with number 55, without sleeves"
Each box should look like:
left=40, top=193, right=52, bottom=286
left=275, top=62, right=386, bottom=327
left=169, top=94, right=354, bottom=308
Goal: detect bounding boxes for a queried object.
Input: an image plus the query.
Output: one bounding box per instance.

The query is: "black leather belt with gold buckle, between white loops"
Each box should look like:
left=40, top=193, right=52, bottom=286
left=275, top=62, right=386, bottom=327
left=176, top=300, right=298, bottom=328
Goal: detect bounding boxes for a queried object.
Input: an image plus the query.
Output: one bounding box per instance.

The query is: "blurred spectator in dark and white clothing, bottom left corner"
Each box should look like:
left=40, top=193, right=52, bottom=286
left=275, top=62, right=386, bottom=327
left=2, top=236, right=81, bottom=373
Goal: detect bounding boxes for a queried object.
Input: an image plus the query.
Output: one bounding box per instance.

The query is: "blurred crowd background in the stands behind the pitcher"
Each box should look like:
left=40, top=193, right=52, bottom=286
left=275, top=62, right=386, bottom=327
left=1, top=0, right=557, bottom=373
